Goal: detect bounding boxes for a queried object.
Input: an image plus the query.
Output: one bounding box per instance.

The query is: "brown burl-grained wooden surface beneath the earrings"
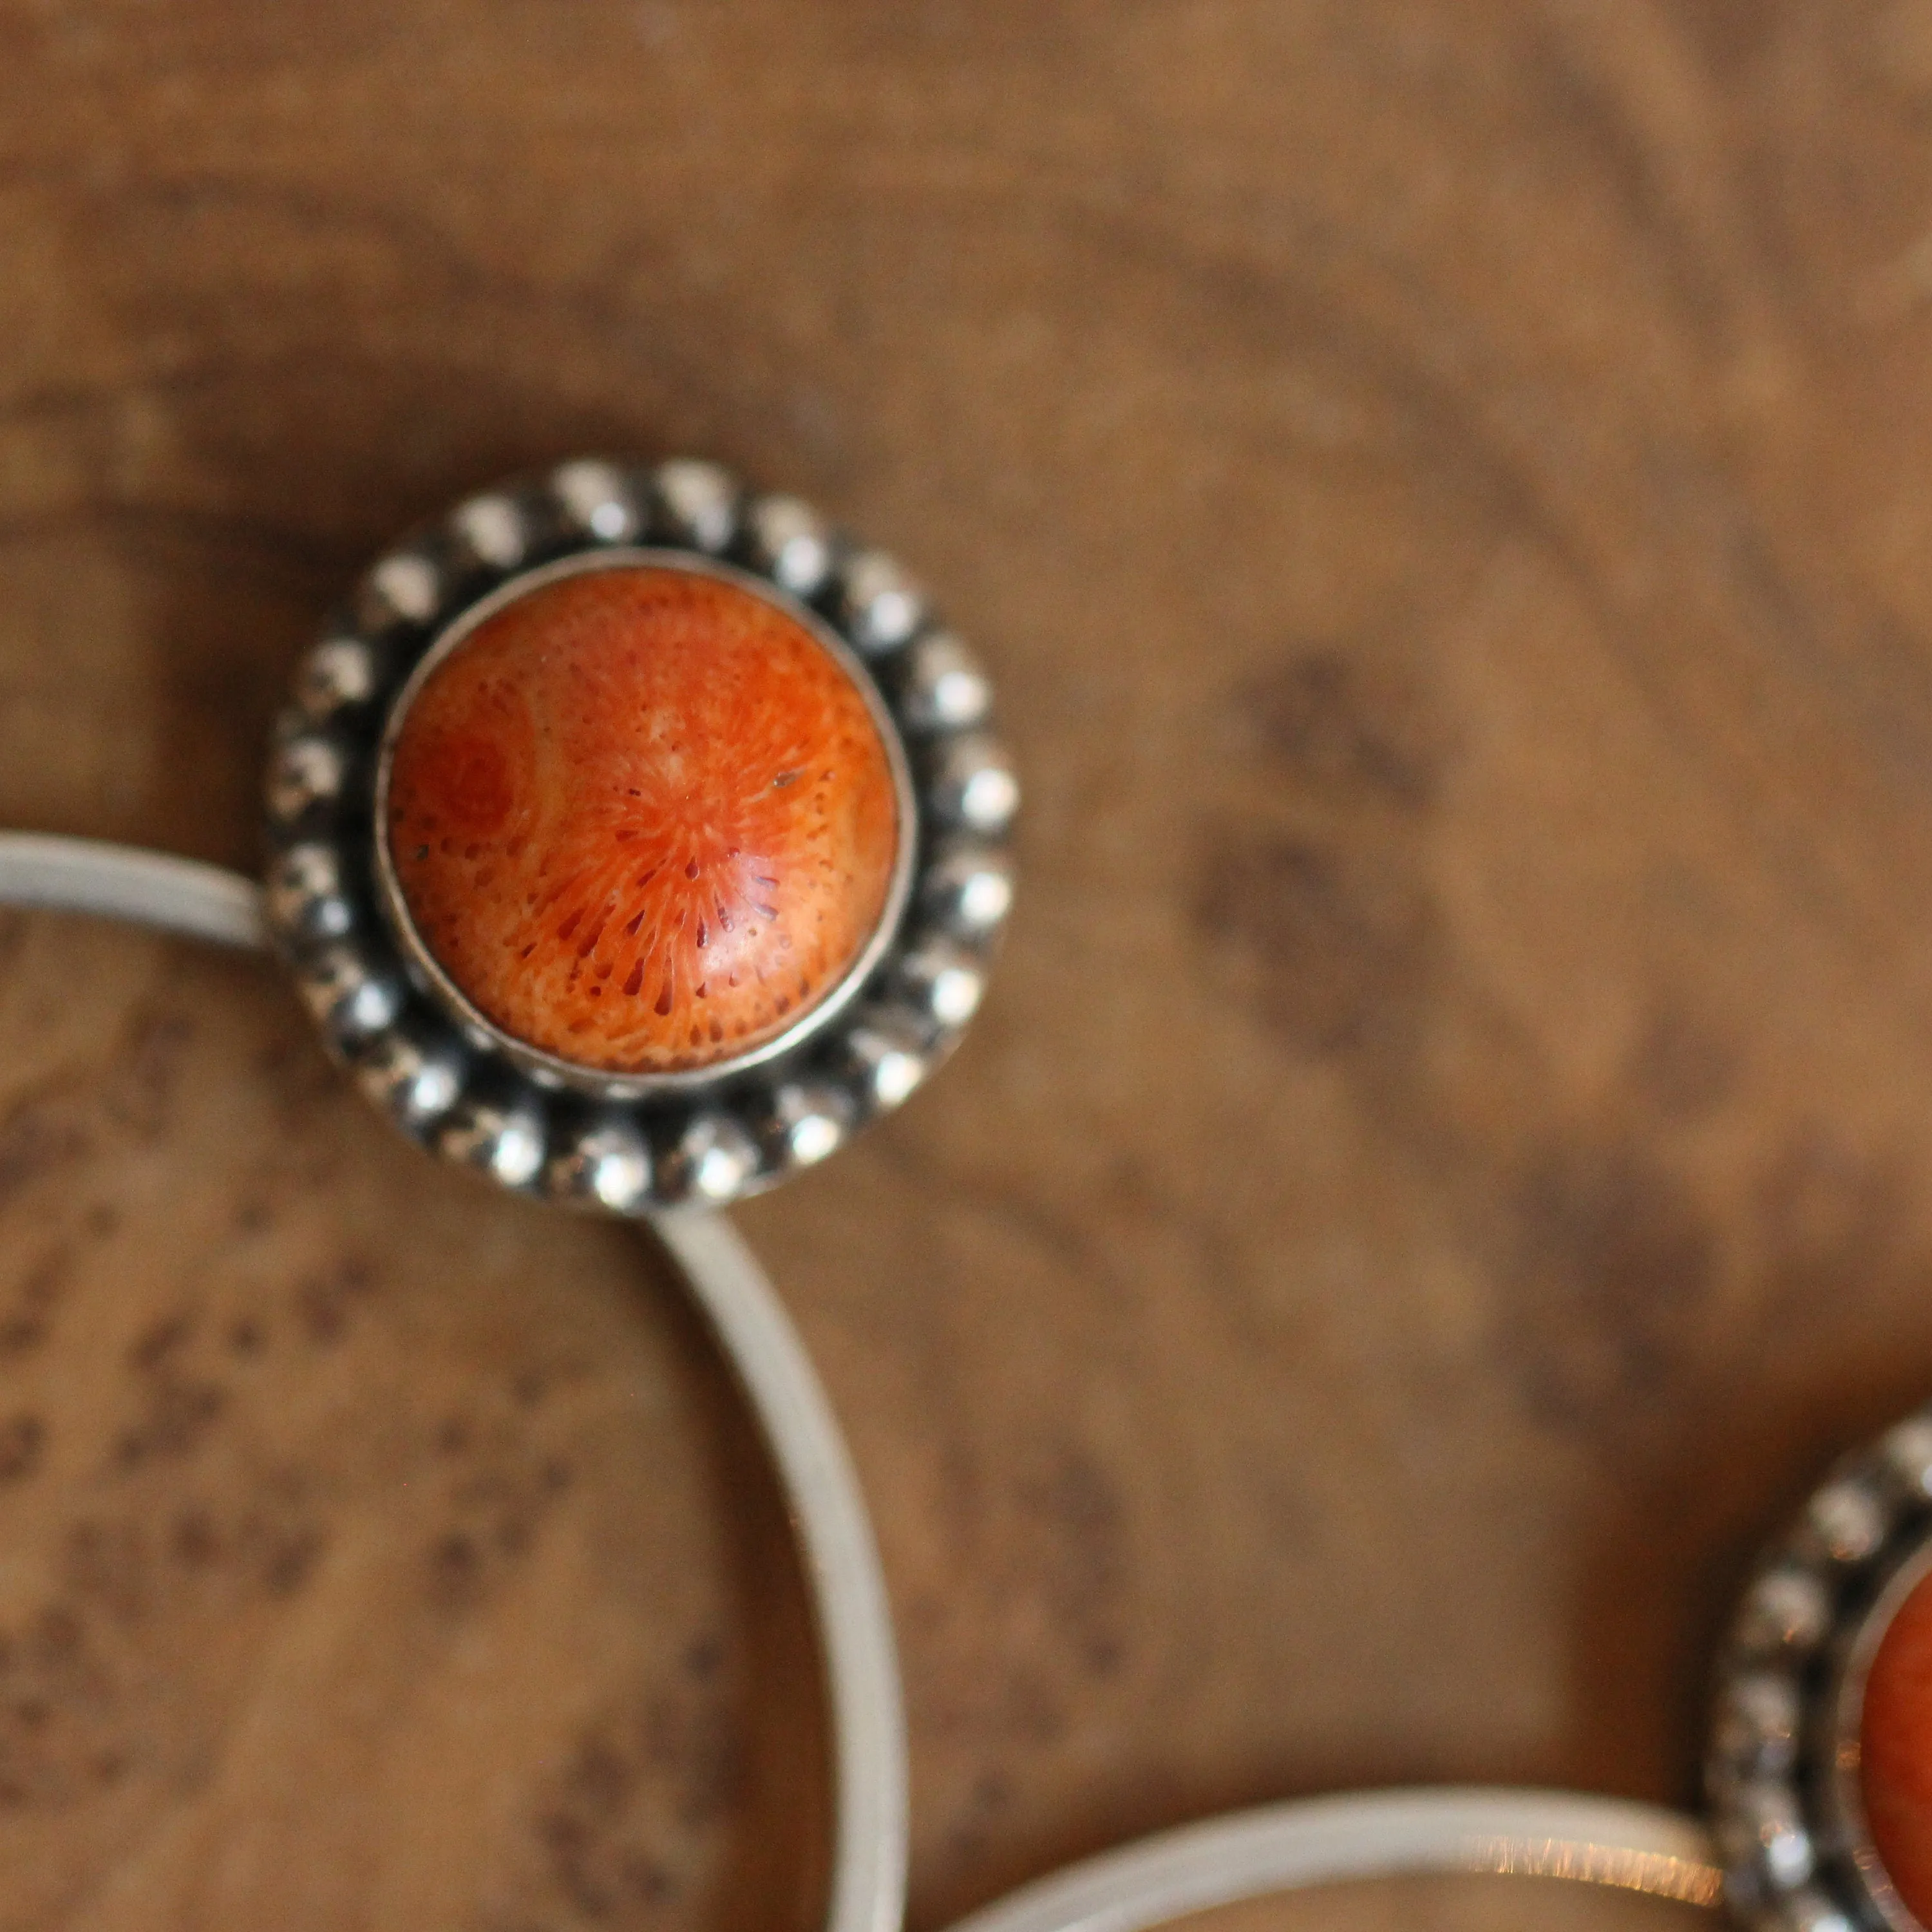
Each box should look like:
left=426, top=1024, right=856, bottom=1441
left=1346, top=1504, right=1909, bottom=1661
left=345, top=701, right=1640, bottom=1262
left=0, top=0, right=1932, bottom=1932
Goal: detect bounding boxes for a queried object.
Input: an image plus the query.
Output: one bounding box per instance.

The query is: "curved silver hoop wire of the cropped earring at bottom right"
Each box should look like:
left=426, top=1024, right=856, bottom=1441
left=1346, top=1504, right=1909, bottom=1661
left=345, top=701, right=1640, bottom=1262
left=935, top=1789, right=1719, bottom=1932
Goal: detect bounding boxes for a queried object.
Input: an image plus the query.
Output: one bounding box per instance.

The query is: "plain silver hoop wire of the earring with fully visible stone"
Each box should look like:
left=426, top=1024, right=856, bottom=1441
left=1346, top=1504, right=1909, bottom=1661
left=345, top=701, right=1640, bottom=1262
left=0, top=833, right=906, bottom=1932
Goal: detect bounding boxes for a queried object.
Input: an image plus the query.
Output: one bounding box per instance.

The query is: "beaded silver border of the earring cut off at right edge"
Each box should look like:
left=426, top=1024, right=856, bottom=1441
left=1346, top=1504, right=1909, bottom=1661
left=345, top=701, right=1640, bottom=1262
left=1704, top=1406, right=1932, bottom=1932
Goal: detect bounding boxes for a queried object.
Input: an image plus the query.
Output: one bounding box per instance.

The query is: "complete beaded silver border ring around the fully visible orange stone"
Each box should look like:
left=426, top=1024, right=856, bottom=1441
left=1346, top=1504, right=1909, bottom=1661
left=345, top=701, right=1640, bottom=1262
left=265, top=458, right=1020, bottom=1215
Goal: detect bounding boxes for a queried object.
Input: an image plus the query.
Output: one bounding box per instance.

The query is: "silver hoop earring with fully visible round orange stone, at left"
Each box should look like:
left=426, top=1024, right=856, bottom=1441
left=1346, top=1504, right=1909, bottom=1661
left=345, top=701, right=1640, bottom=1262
left=0, top=460, right=1018, bottom=1932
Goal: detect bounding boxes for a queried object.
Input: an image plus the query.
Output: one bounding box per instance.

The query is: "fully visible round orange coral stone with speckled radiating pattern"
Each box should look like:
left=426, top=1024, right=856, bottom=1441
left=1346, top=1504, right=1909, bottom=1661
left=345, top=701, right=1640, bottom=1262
left=388, top=564, right=900, bottom=1074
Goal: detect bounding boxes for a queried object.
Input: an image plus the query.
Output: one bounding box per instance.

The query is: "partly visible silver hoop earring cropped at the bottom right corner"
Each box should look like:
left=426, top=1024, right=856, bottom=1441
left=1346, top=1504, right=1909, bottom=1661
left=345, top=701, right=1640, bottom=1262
left=927, top=1408, right=1932, bottom=1932
